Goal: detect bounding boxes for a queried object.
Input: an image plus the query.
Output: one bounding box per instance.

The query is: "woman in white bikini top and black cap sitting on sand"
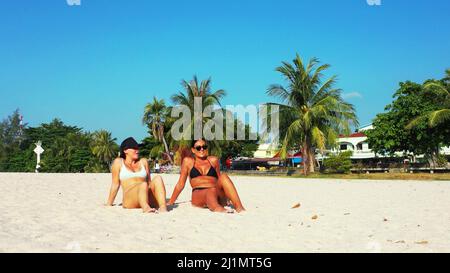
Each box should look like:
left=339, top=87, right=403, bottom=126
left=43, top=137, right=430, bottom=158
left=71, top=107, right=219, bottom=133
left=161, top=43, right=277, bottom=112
left=106, top=137, right=167, bottom=213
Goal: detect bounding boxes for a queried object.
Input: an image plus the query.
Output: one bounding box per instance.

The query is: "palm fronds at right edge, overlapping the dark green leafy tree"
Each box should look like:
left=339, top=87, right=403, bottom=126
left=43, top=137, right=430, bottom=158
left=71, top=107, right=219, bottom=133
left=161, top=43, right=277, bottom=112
left=406, top=69, right=450, bottom=129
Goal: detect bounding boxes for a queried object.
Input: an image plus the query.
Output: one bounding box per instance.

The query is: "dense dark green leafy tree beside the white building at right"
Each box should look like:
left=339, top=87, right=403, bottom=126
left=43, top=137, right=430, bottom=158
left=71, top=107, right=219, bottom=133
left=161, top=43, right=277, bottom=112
left=365, top=76, right=450, bottom=157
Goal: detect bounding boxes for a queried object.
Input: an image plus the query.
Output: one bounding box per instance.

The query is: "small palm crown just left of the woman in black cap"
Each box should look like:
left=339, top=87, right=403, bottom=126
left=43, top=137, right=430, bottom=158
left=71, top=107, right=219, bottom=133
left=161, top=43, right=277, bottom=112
left=91, top=130, right=119, bottom=165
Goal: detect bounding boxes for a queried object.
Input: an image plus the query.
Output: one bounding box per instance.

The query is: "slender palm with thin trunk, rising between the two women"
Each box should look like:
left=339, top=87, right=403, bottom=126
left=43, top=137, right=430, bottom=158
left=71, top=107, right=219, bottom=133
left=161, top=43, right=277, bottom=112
left=142, top=97, right=173, bottom=164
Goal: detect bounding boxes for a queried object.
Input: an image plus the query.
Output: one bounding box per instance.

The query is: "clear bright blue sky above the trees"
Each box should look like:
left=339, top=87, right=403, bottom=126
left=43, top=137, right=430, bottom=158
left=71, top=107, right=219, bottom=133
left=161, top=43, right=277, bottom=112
left=0, top=0, right=450, bottom=142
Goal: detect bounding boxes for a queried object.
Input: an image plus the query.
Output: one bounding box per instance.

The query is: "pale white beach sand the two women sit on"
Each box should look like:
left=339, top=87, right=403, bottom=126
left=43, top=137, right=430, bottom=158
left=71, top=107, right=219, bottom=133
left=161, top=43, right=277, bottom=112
left=0, top=173, right=450, bottom=253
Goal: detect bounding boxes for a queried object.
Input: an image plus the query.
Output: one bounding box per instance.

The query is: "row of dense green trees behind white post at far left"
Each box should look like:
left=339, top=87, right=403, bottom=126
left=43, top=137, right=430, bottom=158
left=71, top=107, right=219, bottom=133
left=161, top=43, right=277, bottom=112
left=0, top=111, right=118, bottom=173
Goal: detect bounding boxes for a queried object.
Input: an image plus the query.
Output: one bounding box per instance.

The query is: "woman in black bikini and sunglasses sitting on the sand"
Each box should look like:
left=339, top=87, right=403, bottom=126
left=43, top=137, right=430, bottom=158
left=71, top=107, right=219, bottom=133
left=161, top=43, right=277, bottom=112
left=168, top=139, right=245, bottom=212
